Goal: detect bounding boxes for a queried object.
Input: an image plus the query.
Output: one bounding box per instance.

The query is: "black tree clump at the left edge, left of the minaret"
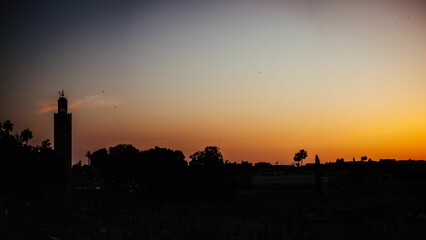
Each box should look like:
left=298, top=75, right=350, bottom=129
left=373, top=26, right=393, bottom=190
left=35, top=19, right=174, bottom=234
left=0, top=121, right=67, bottom=214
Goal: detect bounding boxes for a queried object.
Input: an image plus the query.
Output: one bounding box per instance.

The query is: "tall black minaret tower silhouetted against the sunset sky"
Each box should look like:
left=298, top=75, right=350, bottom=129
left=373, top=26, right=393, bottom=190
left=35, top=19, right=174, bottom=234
left=54, top=90, right=72, bottom=176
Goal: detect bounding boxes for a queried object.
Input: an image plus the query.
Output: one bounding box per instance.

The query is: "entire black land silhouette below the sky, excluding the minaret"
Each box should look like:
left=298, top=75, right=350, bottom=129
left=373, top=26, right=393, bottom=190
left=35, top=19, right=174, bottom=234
left=0, top=120, right=426, bottom=239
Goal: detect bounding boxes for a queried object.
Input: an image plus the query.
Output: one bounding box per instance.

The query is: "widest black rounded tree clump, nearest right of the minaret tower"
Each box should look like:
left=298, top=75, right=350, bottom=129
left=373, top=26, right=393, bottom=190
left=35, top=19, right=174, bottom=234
left=86, top=144, right=187, bottom=199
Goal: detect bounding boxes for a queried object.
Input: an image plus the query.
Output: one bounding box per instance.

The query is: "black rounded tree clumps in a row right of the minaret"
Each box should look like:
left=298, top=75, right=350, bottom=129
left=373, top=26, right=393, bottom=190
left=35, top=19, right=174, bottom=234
left=83, top=144, right=253, bottom=201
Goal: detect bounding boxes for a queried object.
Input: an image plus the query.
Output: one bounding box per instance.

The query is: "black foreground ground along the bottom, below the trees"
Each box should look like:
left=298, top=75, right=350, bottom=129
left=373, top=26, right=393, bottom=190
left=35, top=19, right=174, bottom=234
left=0, top=189, right=426, bottom=240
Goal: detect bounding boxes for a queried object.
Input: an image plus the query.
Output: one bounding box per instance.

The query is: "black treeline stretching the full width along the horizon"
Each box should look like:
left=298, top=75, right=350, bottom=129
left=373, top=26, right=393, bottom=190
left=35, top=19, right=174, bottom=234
left=0, top=120, right=425, bottom=202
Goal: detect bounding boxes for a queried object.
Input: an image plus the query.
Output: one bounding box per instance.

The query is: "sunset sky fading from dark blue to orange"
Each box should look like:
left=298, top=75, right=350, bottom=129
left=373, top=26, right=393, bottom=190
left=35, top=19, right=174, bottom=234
left=0, top=0, right=426, bottom=164
